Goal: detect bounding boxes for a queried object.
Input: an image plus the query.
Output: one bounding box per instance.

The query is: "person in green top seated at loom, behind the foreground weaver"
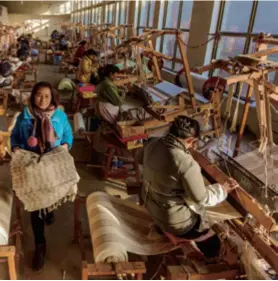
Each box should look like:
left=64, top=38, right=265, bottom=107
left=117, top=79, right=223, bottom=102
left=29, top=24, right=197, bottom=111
left=95, top=64, right=125, bottom=124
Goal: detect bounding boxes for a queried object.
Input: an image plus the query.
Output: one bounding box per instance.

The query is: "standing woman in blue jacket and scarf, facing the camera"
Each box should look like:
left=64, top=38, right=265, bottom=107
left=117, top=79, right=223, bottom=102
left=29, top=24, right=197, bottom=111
left=11, top=82, right=73, bottom=271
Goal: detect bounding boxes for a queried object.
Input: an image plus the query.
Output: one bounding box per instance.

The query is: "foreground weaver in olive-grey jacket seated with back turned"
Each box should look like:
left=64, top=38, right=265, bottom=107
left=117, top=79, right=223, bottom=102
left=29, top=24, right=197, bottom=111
left=138, top=116, right=237, bottom=258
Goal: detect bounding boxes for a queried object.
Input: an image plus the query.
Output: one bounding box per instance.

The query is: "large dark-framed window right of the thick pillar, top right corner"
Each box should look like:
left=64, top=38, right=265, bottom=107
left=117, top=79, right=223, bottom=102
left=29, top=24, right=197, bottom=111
left=206, top=0, right=278, bottom=82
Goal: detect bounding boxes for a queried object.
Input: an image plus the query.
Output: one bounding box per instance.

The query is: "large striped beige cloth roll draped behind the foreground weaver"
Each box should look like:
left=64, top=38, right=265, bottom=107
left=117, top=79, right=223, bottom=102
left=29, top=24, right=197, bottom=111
left=86, top=191, right=175, bottom=262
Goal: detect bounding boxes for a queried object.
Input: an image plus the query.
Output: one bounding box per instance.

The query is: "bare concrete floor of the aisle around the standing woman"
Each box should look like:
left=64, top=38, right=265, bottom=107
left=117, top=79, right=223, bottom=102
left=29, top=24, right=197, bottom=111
left=0, top=62, right=258, bottom=280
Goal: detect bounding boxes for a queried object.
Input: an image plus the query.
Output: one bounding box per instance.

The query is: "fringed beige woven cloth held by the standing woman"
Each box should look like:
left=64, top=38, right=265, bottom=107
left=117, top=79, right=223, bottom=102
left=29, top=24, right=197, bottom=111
left=10, top=147, right=79, bottom=212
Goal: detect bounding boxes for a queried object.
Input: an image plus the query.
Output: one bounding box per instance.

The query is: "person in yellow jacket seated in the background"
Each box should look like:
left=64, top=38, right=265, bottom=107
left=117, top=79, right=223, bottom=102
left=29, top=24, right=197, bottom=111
left=76, top=49, right=99, bottom=85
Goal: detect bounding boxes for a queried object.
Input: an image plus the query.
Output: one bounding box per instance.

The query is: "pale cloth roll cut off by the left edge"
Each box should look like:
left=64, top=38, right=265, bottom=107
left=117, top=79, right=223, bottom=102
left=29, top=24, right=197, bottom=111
left=0, top=166, right=13, bottom=245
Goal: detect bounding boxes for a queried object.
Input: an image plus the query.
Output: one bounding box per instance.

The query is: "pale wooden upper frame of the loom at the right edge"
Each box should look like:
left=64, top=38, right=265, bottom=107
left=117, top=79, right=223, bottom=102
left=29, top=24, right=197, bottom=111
left=195, top=34, right=278, bottom=156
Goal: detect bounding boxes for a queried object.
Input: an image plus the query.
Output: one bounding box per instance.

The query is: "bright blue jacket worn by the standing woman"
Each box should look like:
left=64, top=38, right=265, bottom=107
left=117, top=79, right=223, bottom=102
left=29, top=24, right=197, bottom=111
left=11, top=106, right=73, bottom=152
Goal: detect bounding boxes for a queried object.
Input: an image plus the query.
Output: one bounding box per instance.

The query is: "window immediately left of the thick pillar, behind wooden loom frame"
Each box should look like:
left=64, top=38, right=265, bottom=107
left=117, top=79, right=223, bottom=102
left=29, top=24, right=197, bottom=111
left=156, top=0, right=193, bottom=71
